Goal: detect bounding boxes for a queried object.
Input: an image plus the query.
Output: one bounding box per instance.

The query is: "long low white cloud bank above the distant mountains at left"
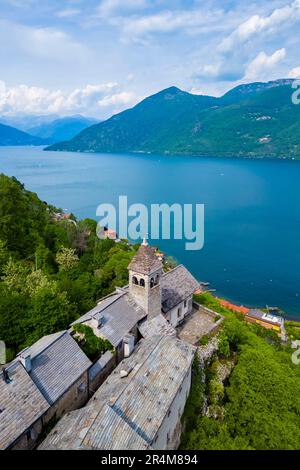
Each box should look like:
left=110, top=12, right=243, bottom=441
left=0, top=81, right=137, bottom=116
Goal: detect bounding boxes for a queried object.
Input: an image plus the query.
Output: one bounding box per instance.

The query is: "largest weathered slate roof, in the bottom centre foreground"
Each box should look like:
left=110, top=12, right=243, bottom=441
left=40, top=336, right=196, bottom=450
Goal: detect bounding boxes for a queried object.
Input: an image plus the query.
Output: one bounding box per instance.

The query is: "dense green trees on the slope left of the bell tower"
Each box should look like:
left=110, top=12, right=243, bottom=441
left=0, top=174, right=136, bottom=360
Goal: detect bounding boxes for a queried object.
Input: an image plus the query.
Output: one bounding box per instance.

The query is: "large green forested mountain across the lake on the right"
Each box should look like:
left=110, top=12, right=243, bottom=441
left=46, top=80, right=300, bottom=159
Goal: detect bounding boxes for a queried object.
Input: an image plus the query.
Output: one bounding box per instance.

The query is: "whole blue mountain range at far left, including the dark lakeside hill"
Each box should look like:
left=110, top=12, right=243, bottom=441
left=0, top=115, right=97, bottom=145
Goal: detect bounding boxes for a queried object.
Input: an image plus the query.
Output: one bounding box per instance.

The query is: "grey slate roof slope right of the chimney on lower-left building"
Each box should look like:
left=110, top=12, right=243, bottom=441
left=16, top=331, right=92, bottom=405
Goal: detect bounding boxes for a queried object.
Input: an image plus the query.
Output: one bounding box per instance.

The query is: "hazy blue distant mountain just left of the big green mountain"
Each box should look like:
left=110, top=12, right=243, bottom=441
left=28, top=115, right=97, bottom=143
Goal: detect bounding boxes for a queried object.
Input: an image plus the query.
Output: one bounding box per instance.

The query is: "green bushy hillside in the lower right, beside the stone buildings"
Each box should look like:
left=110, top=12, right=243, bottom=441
left=181, top=293, right=300, bottom=450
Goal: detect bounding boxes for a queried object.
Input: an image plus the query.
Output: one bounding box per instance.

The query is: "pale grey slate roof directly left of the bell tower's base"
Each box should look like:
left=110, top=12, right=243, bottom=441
left=73, top=291, right=146, bottom=347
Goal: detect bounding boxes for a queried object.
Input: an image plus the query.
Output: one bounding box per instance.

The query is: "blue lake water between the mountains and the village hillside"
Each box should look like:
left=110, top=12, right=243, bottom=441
left=0, top=147, right=300, bottom=318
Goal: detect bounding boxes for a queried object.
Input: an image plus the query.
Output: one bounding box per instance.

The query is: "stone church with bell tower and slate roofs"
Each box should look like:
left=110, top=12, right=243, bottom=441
left=73, top=241, right=199, bottom=362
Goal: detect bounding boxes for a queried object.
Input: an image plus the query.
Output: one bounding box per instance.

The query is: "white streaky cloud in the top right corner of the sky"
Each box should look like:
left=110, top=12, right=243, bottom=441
left=219, top=0, right=300, bottom=52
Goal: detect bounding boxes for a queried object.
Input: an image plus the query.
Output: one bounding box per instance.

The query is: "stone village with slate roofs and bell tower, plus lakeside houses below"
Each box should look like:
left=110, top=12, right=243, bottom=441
left=0, top=239, right=285, bottom=450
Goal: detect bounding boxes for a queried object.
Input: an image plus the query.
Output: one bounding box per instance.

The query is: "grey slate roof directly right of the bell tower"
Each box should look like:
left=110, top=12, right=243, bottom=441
left=161, top=264, right=199, bottom=313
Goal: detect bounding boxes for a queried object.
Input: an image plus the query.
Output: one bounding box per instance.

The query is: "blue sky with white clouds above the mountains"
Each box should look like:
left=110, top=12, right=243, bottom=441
left=0, top=0, right=300, bottom=119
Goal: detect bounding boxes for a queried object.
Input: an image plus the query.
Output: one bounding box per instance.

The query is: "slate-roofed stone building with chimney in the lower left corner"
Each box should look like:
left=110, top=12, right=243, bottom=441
left=0, top=331, right=92, bottom=449
